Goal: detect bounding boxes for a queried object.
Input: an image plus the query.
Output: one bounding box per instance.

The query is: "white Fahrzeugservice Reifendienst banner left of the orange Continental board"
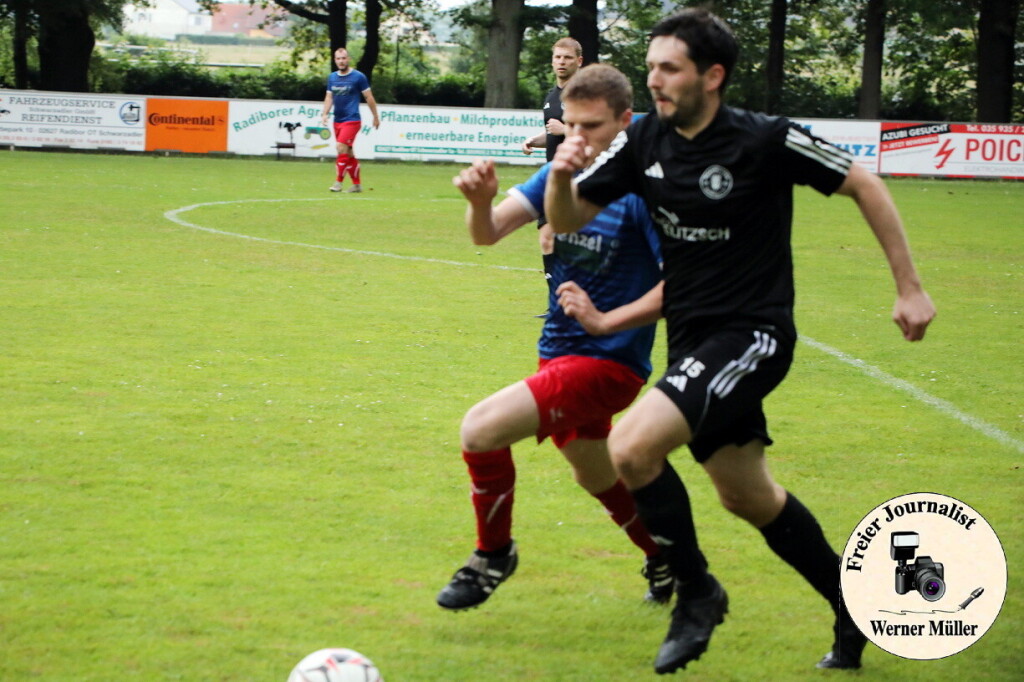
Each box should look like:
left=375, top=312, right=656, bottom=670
left=0, top=90, right=145, bottom=152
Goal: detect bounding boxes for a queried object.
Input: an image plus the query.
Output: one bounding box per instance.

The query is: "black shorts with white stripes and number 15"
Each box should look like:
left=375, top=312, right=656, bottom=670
left=656, top=327, right=794, bottom=462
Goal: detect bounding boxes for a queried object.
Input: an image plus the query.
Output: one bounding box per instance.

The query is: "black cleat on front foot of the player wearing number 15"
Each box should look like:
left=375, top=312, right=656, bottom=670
left=654, top=573, right=729, bottom=675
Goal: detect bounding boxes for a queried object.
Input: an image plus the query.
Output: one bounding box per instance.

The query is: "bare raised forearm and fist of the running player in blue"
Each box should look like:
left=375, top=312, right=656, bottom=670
left=452, top=159, right=534, bottom=246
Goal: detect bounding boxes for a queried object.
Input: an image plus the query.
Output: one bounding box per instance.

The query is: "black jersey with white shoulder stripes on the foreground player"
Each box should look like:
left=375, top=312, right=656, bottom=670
left=577, top=106, right=852, bottom=347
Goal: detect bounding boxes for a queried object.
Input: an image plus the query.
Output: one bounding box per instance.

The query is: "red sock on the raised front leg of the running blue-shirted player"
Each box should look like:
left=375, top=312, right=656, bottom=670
left=464, top=446, right=515, bottom=552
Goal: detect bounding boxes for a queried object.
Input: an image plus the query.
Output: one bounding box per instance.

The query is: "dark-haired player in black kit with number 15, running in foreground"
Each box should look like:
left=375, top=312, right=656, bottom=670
left=545, top=9, right=935, bottom=673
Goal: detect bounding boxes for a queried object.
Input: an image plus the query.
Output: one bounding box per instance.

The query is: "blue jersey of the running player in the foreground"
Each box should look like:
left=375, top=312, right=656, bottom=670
left=509, top=164, right=662, bottom=379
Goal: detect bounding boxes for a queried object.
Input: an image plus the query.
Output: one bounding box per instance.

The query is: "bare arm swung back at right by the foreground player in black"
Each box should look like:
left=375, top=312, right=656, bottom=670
left=837, top=164, right=935, bottom=341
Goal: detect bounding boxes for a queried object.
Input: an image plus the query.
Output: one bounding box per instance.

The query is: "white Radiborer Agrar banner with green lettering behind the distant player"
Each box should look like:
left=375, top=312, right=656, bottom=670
left=227, top=100, right=544, bottom=165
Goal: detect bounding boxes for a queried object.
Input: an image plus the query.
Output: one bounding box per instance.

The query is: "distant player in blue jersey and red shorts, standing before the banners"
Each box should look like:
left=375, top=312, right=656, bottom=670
left=321, top=47, right=381, bottom=193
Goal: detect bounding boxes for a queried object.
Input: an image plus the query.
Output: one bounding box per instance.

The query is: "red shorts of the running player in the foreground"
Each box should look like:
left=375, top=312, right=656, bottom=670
left=525, top=355, right=644, bottom=447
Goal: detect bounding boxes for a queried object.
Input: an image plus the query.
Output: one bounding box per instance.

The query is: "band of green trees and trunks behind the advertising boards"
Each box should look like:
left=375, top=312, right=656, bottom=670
left=0, top=0, right=1024, bottom=121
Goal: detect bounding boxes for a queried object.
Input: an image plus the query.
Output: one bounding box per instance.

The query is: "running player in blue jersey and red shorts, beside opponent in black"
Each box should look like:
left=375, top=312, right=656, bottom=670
left=437, top=65, right=673, bottom=610
